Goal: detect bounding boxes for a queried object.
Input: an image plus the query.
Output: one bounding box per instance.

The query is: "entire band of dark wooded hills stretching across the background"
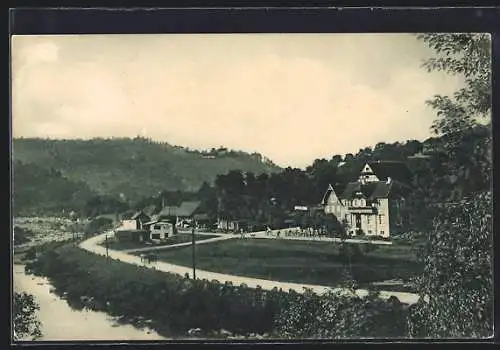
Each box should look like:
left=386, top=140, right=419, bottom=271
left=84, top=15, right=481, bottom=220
left=13, top=123, right=491, bottom=217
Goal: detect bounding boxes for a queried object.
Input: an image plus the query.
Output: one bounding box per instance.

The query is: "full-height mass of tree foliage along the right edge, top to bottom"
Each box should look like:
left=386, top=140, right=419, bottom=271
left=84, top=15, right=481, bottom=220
left=409, top=34, right=493, bottom=337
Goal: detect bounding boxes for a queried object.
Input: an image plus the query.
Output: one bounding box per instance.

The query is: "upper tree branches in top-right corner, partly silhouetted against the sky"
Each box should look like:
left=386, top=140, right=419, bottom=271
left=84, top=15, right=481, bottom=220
left=419, top=34, right=492, bottom=198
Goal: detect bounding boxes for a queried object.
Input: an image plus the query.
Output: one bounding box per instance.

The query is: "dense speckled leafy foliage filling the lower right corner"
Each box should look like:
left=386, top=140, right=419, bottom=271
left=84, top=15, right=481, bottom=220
left=410, top=193, right=494, bottom=338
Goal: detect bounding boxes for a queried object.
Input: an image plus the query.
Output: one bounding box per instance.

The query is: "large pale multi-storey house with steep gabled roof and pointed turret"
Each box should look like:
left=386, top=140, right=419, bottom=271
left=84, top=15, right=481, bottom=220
left=322, top=162, right=411, bottom=238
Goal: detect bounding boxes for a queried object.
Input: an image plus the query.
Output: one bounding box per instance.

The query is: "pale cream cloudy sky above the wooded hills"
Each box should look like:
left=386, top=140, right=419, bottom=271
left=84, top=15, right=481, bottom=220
left=11, top=34, right=462, bottom=168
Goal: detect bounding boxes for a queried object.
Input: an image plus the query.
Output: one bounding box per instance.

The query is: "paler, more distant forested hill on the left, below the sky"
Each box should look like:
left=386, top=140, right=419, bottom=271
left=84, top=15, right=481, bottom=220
left=13, top=137, right=280, bottom=199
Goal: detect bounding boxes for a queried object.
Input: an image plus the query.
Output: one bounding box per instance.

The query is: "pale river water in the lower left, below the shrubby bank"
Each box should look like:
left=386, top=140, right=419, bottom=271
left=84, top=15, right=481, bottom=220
left=13, top=265, right=166, bottom=341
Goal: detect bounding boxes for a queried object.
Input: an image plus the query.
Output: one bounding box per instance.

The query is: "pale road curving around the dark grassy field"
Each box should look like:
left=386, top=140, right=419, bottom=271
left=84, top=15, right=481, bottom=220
left=79, top=228, right=419, bottom=304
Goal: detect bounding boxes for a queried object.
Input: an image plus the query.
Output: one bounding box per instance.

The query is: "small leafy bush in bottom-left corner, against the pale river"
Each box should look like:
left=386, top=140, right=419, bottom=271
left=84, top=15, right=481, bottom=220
left=13, top=292, right=42, bottom=340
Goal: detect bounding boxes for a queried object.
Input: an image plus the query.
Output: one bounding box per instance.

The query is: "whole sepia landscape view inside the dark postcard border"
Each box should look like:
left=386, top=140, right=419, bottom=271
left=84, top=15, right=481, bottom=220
left=11, top=28, right=494, bottom=342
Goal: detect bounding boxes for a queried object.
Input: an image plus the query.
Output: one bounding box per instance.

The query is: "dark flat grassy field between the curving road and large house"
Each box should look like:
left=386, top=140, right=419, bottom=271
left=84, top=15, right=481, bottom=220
left=149, top=239, right=420, bottom=291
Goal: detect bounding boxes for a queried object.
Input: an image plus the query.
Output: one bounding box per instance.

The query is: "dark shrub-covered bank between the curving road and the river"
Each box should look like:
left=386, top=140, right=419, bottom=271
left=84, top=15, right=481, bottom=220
left=26, top=244, right=410, bottom=338
